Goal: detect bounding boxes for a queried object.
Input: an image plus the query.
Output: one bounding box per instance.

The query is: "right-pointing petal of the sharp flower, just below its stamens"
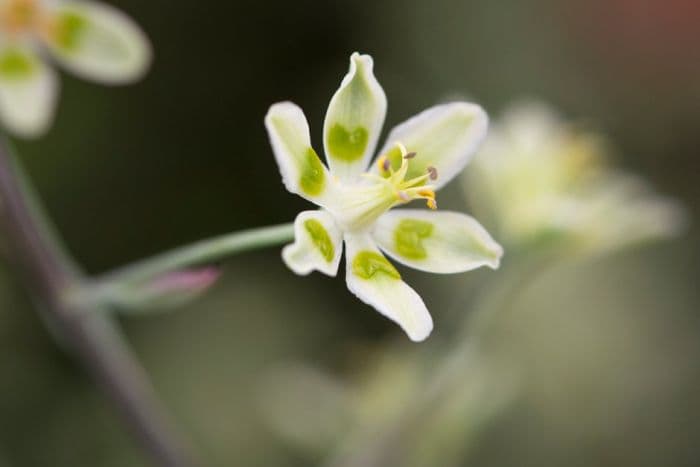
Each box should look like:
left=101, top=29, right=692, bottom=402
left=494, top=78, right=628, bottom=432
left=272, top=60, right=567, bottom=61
left=373, top=209, right=503, bottom=274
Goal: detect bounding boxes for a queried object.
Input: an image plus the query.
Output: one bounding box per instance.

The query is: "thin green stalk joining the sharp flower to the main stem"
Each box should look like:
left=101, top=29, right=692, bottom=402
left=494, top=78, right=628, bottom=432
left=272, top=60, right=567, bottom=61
left=93, top=223, right=294, bottom=288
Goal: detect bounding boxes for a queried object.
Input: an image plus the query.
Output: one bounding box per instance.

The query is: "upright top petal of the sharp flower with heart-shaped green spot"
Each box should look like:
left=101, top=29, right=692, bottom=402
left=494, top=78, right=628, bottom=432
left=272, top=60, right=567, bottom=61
left=323, top=52, right=386, bottom=180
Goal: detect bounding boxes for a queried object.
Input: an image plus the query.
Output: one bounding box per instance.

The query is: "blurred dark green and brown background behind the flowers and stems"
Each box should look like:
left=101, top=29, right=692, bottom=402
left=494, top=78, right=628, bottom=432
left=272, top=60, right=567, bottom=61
left=0, top=0, right=700, bottom=467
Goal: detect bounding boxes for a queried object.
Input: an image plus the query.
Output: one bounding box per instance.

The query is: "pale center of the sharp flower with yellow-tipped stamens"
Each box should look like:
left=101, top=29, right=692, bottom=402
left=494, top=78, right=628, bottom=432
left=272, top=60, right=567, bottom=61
left=334, top=143, right=438, bottom=231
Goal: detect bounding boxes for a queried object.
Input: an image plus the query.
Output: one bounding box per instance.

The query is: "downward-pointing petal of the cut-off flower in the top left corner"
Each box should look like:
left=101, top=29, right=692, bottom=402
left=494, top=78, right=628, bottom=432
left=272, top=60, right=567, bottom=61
left=0, top=45, right=58, bottom=137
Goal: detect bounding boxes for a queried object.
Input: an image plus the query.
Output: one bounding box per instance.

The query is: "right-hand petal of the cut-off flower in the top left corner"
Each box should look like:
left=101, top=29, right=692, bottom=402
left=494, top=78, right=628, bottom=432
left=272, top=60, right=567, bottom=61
left=46, top=1, right=152, bottom=84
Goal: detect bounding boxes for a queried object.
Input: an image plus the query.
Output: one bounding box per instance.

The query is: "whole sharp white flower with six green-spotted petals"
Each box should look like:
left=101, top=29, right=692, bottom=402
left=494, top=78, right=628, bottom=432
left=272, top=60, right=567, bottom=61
left=265, top=53, right=502, bottom=341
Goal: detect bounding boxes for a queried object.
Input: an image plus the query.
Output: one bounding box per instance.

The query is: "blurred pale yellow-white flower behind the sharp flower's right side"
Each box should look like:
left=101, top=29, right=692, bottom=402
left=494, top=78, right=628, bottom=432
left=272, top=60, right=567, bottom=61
left=463, top=102, right=684, bottom=252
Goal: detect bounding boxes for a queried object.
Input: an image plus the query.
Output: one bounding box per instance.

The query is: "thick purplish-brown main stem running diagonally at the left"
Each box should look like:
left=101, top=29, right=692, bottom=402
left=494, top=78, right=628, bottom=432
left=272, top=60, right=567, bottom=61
left=0, top=139, right=200, bottom=467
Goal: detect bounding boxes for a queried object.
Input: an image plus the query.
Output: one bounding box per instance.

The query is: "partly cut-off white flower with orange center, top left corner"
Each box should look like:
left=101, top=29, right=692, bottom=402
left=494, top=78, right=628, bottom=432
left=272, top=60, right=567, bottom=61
left=0, top=0, right=151, bottom=137
